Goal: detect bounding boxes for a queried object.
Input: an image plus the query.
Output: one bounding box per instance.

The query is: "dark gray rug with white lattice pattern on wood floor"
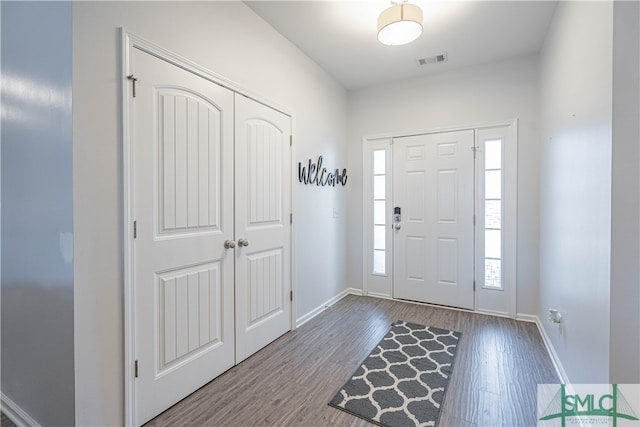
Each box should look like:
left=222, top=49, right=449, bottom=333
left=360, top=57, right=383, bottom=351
left=329, top=321, right=462, bottom=427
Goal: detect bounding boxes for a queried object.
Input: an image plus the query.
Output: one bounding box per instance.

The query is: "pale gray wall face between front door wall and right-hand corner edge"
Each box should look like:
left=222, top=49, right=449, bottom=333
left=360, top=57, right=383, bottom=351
left=539, top=2, right=613, bottom=384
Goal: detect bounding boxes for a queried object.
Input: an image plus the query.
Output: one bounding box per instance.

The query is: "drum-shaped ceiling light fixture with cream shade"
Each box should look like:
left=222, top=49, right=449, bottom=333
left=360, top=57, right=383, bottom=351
left=378, top=0, right=422, bottom=46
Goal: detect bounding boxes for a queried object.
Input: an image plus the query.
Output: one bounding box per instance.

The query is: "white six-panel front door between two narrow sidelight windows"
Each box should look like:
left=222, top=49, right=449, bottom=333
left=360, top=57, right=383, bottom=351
left=393, top=130, right=474, bottom=309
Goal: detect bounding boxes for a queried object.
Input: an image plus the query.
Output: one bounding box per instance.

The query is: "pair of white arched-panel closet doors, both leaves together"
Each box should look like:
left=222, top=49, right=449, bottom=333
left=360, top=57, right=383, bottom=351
left=127, top=48, right=292, bottom=425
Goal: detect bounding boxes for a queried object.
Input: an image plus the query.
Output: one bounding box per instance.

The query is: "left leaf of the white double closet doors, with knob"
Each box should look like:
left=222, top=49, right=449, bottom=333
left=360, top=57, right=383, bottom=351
left=130, top=49, right=235, bottom=425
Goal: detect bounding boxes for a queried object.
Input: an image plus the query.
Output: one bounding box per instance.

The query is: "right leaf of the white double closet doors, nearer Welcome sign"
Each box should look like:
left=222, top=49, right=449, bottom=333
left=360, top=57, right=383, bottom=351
left=235, top=95, right=292, bottom=363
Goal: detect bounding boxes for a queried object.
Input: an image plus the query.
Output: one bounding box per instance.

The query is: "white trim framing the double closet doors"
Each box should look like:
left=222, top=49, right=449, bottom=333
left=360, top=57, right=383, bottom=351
left=119, top=28, right=296, bottom=425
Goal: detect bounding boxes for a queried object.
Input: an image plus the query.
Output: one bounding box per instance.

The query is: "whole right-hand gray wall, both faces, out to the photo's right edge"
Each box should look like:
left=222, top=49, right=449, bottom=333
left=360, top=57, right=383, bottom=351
left=539, top=2, right=640, bottom=383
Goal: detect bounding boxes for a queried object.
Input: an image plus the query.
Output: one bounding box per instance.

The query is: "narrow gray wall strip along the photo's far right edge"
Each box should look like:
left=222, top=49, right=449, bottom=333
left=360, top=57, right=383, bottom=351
left=610, top=1, right=640, bottom=384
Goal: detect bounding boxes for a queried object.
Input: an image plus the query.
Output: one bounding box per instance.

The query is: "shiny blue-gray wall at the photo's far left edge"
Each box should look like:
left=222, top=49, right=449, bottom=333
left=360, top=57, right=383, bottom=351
left=1, top=2, right=75, bottom=426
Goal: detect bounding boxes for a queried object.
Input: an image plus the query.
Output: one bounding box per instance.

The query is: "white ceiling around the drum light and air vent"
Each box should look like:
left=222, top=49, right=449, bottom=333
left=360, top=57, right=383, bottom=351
left=245, top=0, right=556, bottom=90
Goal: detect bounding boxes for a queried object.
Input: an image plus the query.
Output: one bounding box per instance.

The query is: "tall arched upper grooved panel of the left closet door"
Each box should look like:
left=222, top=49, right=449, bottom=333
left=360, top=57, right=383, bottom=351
left=156, top=87, right=222, bottom=233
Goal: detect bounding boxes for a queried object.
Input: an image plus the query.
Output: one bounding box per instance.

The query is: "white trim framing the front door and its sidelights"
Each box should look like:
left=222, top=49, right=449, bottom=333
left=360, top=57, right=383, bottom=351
left=362, top=119, right=518, bottom=318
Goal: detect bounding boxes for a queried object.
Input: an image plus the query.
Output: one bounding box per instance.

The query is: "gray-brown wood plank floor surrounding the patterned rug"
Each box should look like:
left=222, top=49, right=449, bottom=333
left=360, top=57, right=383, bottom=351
left=147, top=295, right=559, bottom=427
